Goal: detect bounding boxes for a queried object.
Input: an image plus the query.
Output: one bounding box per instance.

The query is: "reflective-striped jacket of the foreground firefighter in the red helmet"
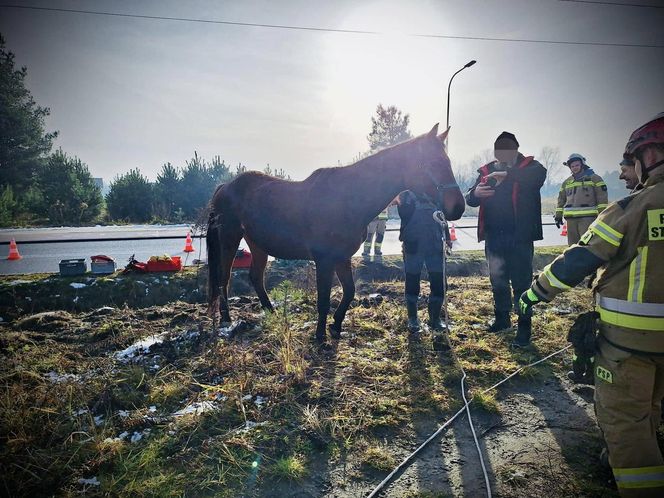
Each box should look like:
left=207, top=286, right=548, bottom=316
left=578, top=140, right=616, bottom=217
left=531, top=167, right=664, bottom=353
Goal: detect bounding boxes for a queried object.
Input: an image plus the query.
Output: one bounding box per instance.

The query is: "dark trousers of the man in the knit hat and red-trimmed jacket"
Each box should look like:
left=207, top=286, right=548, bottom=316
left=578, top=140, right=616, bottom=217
left=484, top=237, right=533, bottom=316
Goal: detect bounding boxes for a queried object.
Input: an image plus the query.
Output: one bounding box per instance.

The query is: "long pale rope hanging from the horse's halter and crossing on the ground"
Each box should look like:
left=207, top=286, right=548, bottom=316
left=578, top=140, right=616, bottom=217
left=367, top=212, right=572, bottom=498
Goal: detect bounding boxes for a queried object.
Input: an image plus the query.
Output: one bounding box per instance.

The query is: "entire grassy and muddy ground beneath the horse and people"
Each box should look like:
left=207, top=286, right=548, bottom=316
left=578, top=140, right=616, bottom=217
left=0, top=251, right=628, bottom=498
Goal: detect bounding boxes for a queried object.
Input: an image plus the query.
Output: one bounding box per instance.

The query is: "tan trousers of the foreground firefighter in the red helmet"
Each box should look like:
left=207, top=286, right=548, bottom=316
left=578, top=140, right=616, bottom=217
left=595, top=332, right=664, bottom=498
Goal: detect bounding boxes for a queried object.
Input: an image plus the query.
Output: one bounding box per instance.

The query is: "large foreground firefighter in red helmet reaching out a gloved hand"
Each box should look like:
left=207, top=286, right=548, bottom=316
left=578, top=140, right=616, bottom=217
left=519, top=113, right=664, bottom=497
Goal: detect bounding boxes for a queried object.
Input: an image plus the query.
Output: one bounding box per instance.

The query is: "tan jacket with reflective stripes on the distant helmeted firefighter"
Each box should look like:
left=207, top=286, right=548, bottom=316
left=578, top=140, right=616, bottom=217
left=556, top=169, right=608, bottom=219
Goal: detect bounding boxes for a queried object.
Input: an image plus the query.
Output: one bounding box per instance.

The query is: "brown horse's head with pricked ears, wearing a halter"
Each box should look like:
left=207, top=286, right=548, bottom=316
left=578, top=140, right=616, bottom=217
left=404, top=124, right=466, bottom=220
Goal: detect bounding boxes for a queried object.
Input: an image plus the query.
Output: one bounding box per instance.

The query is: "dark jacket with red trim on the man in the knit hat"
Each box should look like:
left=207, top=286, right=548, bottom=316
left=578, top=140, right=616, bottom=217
left=466, top=153, right=546, bottom=242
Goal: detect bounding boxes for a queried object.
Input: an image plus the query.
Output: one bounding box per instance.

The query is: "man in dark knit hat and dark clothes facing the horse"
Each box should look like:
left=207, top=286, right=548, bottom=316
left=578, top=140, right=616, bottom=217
left=466, top=131, right=546, bottom=347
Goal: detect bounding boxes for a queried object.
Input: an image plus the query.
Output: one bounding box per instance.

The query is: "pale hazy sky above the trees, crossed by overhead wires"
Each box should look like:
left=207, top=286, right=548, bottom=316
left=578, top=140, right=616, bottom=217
left=0, top=0, right=664, bottom=181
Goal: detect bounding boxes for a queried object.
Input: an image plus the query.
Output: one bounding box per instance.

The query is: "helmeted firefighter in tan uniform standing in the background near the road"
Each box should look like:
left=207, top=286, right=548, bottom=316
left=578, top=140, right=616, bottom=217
left=554, top=153, right=608, bottom=246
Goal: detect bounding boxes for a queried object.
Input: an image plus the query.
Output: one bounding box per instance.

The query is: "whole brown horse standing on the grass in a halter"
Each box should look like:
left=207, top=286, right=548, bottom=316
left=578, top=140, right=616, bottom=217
left=207, top=125, right=465, bottom=341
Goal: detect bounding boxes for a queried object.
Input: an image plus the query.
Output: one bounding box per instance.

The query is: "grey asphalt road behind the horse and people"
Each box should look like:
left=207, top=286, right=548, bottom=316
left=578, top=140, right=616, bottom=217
left=0, top=220, right=566, bottom=275
